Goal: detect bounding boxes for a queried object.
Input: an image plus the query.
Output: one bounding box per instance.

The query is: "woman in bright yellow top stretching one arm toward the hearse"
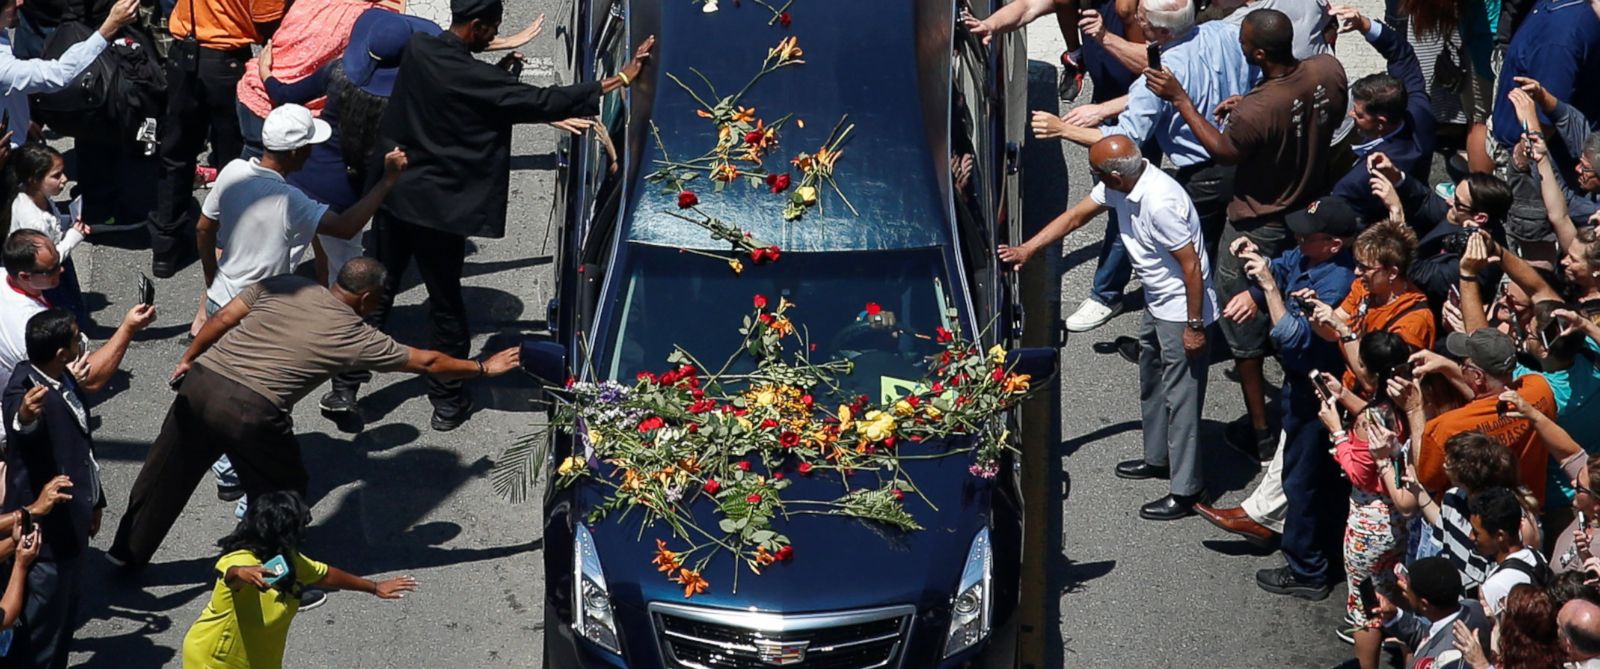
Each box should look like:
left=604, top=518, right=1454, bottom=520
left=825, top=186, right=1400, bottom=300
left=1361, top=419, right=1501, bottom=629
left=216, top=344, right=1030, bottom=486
left=184, top=491, right=416, bottom=669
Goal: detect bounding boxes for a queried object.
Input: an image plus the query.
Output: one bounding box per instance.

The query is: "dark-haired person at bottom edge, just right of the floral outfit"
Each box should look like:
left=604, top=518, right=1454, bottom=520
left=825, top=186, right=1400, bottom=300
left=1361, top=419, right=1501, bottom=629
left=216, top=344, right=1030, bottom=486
left=1379, top=555, right=1491, bottom=669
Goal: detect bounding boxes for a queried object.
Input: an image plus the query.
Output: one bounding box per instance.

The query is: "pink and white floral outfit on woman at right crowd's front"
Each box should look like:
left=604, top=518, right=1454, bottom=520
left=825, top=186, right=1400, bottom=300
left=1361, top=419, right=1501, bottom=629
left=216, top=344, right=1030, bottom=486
left=1333, top=437, right=1406, bottom=629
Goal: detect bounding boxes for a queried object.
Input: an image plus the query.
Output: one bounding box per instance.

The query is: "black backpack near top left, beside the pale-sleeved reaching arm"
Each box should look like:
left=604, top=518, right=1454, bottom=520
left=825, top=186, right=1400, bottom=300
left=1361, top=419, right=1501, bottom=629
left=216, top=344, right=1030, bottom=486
left=32, top=21, right=166, bottom=142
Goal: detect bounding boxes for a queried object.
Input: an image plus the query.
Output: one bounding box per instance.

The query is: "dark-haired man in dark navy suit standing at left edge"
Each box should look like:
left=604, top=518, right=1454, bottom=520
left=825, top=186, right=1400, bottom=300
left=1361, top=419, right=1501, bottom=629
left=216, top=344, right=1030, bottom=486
left=0, top=309, right=106, bottom=669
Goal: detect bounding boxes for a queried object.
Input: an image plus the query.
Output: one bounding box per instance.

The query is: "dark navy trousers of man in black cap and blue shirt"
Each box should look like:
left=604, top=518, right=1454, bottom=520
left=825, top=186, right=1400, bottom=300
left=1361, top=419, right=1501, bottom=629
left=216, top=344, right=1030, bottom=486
left=1282, top=375, right=1350, bottom=581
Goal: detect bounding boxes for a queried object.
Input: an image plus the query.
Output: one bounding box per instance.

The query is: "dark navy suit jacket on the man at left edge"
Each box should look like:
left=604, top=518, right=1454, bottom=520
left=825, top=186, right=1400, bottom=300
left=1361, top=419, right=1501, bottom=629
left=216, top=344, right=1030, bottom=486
left=0, top=360, right=106, bottom=560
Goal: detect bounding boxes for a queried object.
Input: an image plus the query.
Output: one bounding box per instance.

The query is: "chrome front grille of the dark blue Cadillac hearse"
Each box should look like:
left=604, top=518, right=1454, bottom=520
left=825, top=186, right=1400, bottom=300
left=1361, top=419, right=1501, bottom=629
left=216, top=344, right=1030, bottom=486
left=645, top=602, right=917, bottom=669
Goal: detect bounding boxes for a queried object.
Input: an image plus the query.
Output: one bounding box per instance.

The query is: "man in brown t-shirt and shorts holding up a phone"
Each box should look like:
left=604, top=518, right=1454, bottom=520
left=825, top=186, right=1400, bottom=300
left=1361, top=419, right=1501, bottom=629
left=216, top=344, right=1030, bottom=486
left=1144, top=10, right=1349, bottom=453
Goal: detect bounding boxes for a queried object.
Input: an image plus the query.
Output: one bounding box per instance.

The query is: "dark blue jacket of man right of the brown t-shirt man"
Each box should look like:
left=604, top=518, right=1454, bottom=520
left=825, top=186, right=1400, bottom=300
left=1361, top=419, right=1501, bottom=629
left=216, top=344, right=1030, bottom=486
left=1333, top=21, right=1438, bottom=221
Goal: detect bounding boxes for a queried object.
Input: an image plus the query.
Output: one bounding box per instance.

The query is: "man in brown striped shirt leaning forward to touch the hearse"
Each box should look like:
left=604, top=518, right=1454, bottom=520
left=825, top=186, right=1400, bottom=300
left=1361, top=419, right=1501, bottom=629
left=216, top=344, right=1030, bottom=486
left=109, top=258, right=518, bottom=567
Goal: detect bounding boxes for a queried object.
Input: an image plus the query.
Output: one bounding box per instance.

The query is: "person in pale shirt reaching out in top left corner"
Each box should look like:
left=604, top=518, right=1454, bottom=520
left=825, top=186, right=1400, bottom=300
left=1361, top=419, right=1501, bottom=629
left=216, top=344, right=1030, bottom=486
left=0, top=0, right=139, bottom=147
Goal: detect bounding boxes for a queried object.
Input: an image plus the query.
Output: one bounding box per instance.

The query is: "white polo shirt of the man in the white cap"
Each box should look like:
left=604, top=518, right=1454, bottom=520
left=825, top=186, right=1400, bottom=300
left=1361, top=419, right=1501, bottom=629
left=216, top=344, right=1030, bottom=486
left=200, top=158, right=328, bottom=304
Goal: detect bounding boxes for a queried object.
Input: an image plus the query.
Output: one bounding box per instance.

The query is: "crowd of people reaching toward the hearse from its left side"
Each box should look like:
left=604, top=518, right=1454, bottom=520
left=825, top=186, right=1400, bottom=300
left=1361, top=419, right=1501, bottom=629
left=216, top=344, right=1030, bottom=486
left=0, top=0, right=654, bottom=669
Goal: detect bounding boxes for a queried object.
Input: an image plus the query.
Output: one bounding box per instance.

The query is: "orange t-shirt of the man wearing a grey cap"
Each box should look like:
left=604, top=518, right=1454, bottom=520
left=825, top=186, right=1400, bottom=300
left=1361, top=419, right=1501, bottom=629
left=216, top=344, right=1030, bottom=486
left=1416, top=375, right=1555, bottom=504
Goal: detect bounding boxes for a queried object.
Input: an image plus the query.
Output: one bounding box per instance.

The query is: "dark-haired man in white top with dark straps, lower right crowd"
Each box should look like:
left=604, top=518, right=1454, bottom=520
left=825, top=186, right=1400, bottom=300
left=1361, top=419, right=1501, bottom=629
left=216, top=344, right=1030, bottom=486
left=1467, top=488, right=1550, bottom=616
